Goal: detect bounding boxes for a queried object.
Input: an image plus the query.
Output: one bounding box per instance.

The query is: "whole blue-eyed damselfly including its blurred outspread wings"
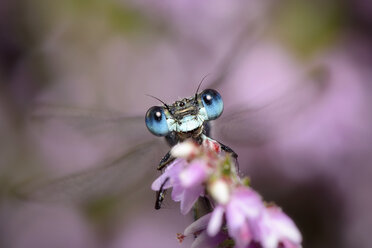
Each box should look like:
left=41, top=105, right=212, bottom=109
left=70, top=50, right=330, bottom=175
left=24, top=69, right=323, bottom=212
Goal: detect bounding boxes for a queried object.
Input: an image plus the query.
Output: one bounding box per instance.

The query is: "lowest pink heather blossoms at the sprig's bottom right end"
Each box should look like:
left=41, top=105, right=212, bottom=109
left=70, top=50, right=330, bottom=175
left=207, top=186, right=302, bottom=248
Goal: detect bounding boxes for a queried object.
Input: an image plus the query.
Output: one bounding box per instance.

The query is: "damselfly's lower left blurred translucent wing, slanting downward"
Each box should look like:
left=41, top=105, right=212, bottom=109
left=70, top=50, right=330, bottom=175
left=23, top=141, right=166, bottom=203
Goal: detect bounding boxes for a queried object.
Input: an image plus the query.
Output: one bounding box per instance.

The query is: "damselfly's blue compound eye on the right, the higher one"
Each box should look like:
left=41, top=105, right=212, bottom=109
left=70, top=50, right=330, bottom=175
left=201, top=89, right=223, bottom=120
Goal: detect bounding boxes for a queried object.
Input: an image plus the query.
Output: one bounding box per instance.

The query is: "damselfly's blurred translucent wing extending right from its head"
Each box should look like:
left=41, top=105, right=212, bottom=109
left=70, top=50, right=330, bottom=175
left=212, top=69, right=327, bottom=146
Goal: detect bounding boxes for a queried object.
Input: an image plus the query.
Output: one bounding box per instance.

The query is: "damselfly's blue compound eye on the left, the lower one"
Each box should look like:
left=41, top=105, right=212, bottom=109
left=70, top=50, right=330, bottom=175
left=145, top=106, right=169, bottom=136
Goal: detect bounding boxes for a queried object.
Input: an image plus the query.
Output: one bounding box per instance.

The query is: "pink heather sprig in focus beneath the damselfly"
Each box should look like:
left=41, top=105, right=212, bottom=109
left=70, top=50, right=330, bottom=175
left=152, top=138, right=302, bottom=248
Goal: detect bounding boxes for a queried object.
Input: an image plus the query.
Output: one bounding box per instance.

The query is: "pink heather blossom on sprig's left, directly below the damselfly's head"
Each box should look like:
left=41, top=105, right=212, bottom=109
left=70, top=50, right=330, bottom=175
left=151, top=159, right=208, bottom=214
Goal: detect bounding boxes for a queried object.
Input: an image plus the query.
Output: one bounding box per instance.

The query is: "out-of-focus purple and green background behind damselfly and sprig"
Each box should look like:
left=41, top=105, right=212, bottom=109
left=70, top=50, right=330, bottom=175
left=0, top=0, right=372, bottom=248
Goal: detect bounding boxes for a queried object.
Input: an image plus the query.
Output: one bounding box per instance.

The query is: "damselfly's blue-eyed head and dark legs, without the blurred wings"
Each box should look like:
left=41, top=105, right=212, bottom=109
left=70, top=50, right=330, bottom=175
left=145, top=84, right=238, bottom=209
